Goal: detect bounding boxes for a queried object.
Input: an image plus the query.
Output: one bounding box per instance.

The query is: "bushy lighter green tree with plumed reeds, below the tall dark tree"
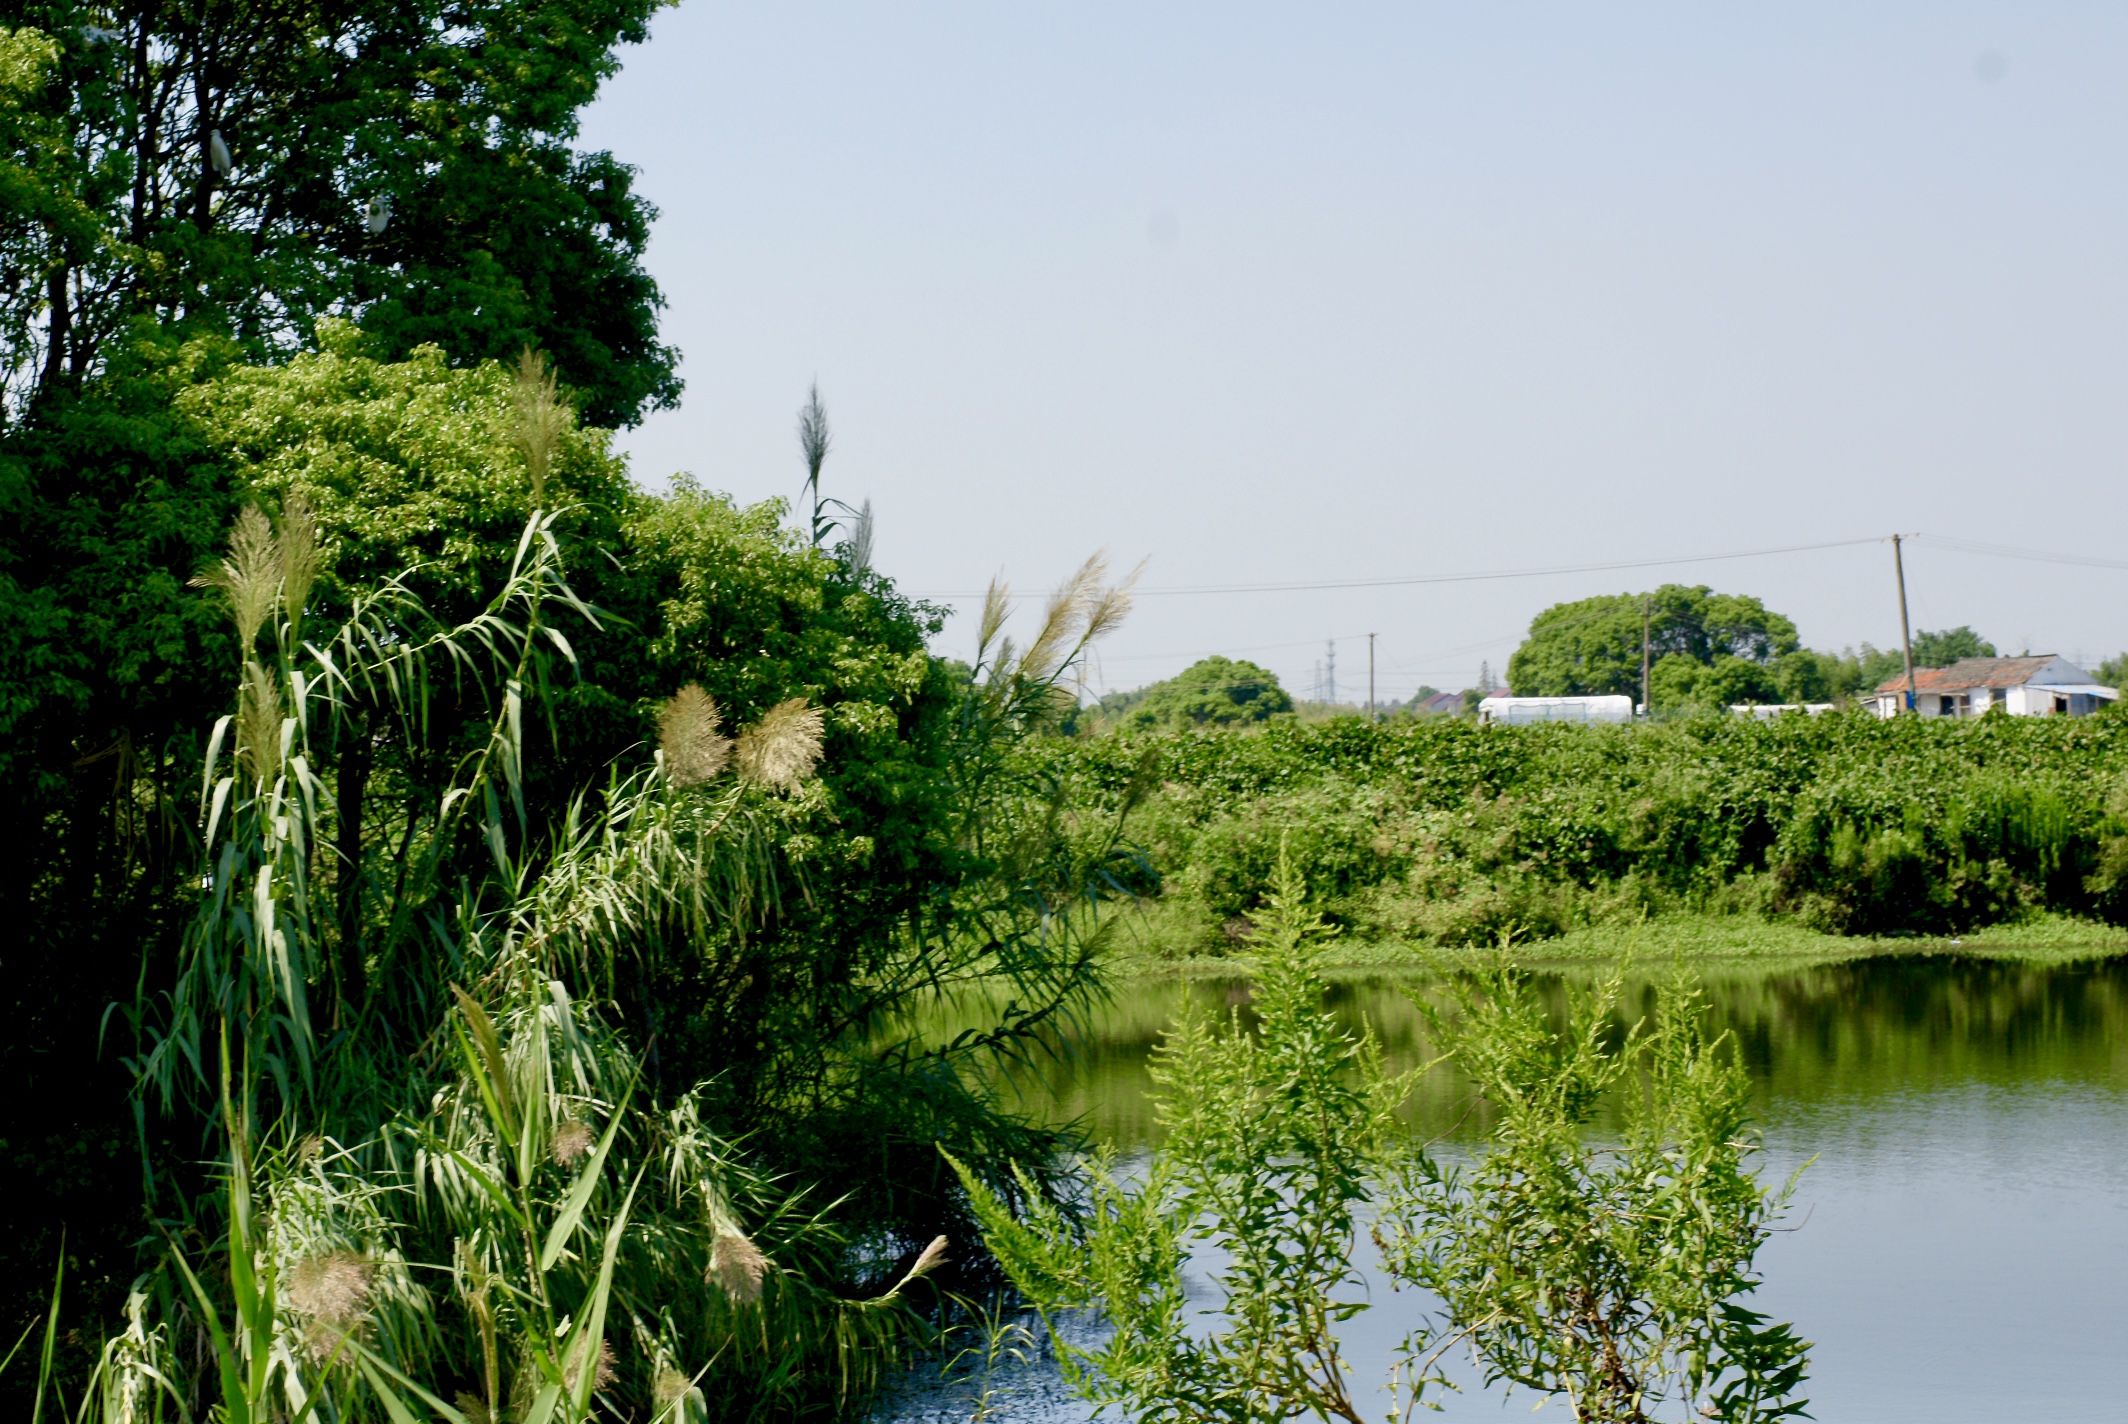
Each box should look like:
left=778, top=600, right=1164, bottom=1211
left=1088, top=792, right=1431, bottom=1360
left=9, top=324, right=1134, bottom=1420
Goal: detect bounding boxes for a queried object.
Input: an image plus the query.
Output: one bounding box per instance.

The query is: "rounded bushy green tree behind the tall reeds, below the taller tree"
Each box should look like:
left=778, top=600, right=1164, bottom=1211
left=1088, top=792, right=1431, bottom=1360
left=0, top=334, right=1132, bottom=1379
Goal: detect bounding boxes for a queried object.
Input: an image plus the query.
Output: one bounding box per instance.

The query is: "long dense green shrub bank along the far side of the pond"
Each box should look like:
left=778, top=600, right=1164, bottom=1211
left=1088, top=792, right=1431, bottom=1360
left=1049, top=713, right=2128, bottom=951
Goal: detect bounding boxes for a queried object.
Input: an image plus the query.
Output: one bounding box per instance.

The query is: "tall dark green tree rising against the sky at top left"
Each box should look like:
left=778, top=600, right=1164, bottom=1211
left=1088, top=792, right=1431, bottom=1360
left=0, top=0, right=679, bottom=426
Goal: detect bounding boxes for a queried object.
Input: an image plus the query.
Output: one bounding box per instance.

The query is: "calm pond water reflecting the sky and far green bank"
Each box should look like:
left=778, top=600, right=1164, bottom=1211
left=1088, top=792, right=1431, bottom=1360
left=872, top=956, right=2128, bottom=1424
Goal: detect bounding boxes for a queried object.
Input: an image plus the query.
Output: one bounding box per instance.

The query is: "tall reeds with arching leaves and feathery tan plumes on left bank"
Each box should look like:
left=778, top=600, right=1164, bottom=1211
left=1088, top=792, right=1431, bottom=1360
left=33, top=464, right=1121, bottom=1422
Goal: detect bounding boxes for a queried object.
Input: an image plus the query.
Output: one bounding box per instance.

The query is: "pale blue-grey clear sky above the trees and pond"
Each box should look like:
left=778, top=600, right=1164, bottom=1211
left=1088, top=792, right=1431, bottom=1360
left=581, top=0, right=2128, bottom=702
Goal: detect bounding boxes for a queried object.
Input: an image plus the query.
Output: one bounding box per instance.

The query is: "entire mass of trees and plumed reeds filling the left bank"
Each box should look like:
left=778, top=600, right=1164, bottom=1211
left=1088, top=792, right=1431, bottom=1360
left=0, top=11, right=1145, bottom=1424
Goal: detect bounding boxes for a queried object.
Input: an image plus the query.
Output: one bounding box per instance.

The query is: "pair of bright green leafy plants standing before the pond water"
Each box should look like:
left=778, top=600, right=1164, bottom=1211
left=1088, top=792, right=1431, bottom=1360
left=962, top=855, right=1807, bottom=1424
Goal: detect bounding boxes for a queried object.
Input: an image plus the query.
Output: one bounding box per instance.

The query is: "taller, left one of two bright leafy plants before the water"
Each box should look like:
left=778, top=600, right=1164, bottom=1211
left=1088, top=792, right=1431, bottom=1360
left=955, top=855, right=1409, bottom=1424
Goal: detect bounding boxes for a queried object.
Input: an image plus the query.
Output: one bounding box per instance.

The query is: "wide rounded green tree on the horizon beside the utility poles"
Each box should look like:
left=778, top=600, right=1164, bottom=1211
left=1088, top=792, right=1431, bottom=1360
left=1507, top=583, right=1796, bottom=700
